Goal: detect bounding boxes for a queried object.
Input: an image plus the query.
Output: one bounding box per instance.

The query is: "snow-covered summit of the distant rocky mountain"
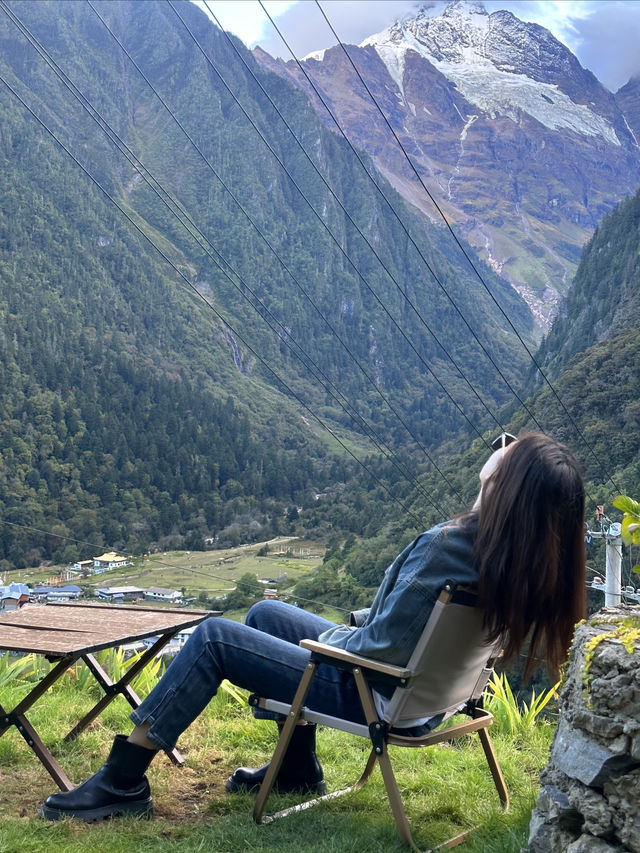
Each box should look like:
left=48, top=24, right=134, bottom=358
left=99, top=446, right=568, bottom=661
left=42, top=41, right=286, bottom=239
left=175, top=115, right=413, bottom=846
left=360, top=0, right=620, bottom=145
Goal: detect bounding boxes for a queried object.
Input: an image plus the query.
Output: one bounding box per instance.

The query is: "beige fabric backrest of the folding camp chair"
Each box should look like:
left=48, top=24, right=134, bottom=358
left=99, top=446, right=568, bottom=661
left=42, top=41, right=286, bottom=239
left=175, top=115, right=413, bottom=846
left=384, top=585, right=500, bottom=725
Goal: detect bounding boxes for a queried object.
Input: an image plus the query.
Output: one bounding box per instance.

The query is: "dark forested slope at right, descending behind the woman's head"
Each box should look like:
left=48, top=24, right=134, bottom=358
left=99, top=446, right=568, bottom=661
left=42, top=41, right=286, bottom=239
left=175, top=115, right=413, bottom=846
left=304, top=191, right=640, bottom=601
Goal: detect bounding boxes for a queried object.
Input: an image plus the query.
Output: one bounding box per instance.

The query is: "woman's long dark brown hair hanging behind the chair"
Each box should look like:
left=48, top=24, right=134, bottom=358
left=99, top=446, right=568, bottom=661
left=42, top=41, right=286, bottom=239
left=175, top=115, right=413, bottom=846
left=462, top=433, right=586, bottom=678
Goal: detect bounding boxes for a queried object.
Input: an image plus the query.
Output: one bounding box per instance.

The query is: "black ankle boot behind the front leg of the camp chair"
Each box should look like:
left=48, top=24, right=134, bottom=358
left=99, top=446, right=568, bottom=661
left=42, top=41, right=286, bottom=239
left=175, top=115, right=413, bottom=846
left=225, top=725, right=327, bottom=794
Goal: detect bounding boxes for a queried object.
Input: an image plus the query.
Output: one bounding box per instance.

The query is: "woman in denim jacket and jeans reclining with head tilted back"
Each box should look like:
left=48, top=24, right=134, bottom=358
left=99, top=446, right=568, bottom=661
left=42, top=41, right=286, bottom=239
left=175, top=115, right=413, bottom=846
left=40, top=433, right=586, bottom=822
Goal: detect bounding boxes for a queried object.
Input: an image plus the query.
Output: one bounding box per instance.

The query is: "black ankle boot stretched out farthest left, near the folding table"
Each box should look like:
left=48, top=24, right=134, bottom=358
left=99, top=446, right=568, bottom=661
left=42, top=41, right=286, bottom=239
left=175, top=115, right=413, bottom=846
left=40, top=735, right=156, bottom=823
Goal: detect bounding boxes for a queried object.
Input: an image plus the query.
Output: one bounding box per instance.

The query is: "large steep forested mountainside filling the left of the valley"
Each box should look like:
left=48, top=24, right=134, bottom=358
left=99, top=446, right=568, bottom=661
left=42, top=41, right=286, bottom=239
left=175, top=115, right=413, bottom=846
left=0, top=5, right=532, bottom=567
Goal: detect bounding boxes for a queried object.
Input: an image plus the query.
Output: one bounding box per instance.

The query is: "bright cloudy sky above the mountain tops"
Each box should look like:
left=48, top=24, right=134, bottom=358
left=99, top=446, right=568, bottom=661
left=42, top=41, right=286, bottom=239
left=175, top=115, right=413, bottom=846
left=199, top=0, right=640, bottom=92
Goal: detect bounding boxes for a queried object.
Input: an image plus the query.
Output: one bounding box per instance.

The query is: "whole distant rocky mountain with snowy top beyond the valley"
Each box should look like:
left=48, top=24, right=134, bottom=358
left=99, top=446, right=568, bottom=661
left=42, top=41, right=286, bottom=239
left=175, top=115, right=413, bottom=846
left=256, top=0, right=640, bottom=328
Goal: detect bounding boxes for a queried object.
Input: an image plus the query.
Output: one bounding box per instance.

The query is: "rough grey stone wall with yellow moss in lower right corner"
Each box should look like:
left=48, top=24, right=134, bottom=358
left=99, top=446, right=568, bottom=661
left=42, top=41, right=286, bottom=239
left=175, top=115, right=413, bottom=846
left=529, top=607, right=640, bottom=853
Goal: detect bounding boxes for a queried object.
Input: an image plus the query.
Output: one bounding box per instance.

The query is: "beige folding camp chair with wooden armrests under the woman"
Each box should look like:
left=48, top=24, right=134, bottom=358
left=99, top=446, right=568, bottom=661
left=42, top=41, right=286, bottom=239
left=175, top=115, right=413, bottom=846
left=249, top=584, right=509, bottom=851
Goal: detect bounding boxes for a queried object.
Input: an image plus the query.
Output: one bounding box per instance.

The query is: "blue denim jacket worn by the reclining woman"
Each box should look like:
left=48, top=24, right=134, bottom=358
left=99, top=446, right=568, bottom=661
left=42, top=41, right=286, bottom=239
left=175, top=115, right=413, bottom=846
left=318, top=522, right=478, bottom=694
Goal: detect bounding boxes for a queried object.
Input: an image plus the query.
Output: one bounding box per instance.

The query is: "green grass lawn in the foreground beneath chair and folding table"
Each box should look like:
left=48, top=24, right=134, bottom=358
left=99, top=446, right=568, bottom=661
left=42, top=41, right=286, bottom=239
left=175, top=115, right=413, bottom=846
left=0, top=679, right=553, bottom=853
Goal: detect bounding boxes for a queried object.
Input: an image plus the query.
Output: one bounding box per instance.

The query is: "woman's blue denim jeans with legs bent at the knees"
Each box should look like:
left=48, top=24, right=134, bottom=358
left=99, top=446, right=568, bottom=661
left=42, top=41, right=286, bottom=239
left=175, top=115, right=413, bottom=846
left=131, top=601, right=365, bottom=749
